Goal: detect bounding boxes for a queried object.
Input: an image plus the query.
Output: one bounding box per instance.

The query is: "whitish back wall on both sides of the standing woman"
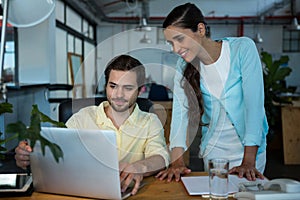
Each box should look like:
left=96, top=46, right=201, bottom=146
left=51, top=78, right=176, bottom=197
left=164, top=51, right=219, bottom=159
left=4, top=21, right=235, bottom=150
left=98, top=24, right=300, bottom=92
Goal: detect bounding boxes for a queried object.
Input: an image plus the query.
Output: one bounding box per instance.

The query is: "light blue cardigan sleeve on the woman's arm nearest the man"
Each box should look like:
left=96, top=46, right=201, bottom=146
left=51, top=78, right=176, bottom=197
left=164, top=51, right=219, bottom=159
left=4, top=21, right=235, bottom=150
left=170, top=58, right=188, bottom=150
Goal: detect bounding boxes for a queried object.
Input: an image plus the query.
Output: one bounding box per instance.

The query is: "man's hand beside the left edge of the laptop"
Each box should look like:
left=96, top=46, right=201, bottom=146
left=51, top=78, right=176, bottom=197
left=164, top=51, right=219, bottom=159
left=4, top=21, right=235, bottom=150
left=15, top=141, right=32, bottom=169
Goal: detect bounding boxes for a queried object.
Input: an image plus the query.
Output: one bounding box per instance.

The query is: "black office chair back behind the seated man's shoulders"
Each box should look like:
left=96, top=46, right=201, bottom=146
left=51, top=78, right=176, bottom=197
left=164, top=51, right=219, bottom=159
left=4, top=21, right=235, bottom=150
left=58, top=97, right=153, bottom=123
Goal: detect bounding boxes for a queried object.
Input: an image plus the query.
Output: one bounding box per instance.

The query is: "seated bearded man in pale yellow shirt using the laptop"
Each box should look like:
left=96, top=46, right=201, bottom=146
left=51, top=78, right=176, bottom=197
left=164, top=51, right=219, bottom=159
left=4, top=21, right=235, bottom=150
left=15, top=55, right=169, bottom=195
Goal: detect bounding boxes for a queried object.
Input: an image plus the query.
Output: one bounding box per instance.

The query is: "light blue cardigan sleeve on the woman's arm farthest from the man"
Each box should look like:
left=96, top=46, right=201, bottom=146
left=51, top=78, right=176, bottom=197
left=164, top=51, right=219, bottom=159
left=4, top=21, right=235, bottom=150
left=239, top=38, right=265, bottom=146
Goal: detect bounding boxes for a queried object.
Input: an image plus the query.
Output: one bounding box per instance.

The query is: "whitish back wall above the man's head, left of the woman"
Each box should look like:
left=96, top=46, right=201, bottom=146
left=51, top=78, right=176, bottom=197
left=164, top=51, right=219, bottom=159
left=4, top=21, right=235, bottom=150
left=97, top=24, right=176, bottom=91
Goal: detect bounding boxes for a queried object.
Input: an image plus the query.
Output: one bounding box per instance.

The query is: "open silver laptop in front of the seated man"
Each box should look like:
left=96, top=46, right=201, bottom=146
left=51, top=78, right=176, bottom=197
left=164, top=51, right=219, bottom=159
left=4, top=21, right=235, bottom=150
left=30, top=127, right=130, bottom=199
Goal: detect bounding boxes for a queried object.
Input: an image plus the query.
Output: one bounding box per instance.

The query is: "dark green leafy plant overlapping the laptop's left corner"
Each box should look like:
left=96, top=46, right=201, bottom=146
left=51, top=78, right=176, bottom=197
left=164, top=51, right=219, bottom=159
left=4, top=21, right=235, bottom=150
left=0, top=103, right=66, bottom=162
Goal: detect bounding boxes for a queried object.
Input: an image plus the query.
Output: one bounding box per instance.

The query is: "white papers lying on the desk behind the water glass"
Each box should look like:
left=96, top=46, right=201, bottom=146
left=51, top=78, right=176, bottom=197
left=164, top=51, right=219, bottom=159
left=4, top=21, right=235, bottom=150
left=181, top=175, right=265, bottom=195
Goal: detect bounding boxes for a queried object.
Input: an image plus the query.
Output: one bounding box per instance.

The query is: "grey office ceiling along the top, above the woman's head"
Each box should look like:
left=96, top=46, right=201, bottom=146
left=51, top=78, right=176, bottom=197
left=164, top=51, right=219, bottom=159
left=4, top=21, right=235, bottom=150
left=64, top=0, right=299, bottom=24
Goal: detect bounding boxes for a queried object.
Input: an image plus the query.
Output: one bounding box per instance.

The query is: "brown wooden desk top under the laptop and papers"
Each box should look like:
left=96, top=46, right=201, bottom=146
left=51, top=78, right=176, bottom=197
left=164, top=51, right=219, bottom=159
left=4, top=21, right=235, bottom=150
left=6, top=172, right=236, bottom=200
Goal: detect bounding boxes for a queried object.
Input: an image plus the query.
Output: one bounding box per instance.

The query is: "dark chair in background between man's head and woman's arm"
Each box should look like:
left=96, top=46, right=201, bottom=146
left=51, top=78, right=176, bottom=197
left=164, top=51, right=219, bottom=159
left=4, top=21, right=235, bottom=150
left=148, top=83, right=169, bottom=101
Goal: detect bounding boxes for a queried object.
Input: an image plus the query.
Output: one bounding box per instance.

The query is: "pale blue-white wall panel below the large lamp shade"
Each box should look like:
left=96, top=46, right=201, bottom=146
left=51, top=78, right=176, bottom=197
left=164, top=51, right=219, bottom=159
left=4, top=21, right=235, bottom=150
left=18, top=11, right=56, bottom=83
